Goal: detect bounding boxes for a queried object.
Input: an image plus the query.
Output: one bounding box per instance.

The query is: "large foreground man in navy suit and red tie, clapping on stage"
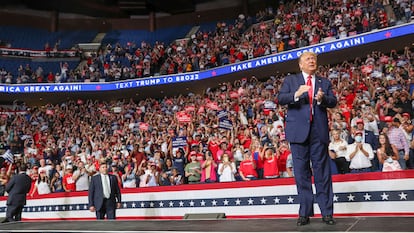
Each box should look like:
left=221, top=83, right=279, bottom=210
left=278, top=52, right=337, bottom=226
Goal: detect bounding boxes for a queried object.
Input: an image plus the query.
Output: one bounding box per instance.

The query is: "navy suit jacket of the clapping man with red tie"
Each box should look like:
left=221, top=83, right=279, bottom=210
left=278, top=73, right=337, bottom=144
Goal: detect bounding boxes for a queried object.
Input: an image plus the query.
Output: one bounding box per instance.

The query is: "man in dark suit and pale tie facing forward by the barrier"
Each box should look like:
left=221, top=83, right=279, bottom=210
left=88, top=162, right=121, bottom=219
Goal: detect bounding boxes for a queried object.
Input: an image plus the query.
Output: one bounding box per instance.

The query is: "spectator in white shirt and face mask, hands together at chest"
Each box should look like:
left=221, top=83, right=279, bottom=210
left=346, top=131, right=374, bottom=173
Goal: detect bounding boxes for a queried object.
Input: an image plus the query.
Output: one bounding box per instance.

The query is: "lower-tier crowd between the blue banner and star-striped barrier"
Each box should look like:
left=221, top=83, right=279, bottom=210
left=0, top=43, right=414, bottom=196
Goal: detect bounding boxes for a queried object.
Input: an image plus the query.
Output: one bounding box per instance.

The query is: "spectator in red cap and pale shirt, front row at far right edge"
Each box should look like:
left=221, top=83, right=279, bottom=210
left=384, top=116, right=410, bottom=170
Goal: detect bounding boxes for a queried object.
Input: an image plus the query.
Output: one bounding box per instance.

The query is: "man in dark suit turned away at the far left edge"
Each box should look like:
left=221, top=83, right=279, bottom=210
left=3, top=164, right=32, bottom=222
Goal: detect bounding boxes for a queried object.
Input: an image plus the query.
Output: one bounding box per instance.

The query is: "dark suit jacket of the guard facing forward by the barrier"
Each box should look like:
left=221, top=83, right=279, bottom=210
left=88, top=173, right=121, bottom=210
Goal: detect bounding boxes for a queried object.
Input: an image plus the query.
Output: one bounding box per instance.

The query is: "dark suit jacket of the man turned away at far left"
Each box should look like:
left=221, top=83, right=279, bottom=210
left=6, top=173, right=32, bottom=206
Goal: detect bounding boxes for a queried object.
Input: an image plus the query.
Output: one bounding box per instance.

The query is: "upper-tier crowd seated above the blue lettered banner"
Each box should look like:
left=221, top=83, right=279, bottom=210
left=0, top=0, right=414, bottom=83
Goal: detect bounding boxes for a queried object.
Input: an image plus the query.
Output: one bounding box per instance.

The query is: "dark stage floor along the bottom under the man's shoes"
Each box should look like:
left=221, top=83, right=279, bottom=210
left=0, top=217, right=414, bottom=233
